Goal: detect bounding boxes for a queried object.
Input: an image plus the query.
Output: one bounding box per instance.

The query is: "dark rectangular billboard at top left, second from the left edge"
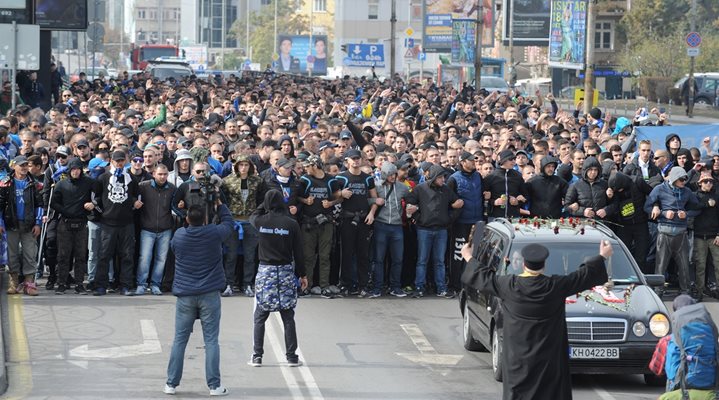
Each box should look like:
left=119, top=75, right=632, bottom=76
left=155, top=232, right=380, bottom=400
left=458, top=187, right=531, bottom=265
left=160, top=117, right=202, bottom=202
left=35, top=0, right=87, bottom=30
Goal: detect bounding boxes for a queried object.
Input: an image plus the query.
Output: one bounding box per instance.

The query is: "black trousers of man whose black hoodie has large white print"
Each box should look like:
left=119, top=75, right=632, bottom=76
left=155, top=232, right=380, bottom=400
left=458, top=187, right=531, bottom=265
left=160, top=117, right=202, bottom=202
left=95, top=224, right=135, bottom=289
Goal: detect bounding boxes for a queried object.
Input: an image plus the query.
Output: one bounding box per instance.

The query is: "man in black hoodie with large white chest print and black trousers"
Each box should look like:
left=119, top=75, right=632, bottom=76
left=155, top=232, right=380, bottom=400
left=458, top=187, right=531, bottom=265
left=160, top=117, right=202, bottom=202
left=93, top=151, right=142, bottom=296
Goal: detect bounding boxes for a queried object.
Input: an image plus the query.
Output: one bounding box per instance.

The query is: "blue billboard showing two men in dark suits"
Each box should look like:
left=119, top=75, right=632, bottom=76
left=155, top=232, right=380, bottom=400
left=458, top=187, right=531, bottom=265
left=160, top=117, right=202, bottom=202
left=276, top=35, right=329, bottom=75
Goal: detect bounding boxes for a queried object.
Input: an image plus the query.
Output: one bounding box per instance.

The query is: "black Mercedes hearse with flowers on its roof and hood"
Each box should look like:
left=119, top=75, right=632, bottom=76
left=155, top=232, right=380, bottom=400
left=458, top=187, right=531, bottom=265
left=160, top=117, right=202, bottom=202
left=458, top=219, right=671, bottom=385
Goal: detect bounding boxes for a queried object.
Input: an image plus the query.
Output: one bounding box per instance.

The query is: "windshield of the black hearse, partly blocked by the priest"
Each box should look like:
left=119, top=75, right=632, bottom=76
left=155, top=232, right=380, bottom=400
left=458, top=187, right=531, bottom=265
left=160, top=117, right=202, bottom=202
left=504, top=243, right=641, bottom=284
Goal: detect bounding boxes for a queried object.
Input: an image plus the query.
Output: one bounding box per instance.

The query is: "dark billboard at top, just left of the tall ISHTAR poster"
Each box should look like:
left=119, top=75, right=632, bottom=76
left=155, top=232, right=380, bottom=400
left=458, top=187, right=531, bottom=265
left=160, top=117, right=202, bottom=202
left=502, top=0, right=551, bottom=46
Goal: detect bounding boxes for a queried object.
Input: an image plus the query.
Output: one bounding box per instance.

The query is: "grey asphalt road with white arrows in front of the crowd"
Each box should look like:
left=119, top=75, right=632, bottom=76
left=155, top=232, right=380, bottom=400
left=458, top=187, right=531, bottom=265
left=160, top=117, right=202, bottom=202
left=2, top=282, right=688, bottom=400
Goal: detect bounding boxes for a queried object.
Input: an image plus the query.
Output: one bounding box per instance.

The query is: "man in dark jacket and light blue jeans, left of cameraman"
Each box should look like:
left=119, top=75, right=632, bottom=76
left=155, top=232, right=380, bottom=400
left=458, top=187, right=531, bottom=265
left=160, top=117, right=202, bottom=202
left=135, top=164, right=176, bottom=296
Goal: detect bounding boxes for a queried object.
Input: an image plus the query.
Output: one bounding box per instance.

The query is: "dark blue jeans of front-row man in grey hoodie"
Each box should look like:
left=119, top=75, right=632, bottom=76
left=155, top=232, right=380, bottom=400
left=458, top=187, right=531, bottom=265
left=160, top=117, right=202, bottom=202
left=374, top=221, right=404, bottom=291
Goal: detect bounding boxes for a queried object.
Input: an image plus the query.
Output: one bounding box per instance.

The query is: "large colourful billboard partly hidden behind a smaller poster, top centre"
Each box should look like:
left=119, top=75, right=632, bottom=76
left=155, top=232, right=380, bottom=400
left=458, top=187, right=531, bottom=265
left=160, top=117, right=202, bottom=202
left=422, top=0, right=494, bottom=53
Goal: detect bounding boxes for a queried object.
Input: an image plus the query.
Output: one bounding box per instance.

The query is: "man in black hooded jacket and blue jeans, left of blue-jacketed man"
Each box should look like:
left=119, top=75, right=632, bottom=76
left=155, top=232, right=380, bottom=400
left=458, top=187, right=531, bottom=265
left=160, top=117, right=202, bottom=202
left=407, top=165, right=464, bottom=298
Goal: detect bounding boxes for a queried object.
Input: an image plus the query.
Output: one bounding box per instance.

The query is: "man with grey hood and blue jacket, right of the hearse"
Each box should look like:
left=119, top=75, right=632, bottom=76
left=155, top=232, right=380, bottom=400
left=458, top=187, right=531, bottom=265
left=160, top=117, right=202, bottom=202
left=644, top=167, right=701, bottom=297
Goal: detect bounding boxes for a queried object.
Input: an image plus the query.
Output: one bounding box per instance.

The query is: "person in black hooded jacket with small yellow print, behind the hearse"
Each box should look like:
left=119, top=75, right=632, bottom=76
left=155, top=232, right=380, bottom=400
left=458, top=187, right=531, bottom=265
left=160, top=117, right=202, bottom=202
left=608, top=171, right=652, bottom=274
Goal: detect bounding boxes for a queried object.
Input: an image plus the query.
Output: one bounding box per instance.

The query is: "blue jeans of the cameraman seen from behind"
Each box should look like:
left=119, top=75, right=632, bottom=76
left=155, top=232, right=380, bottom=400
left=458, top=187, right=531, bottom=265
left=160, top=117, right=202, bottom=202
left=167, top=290, right=222, bottom=389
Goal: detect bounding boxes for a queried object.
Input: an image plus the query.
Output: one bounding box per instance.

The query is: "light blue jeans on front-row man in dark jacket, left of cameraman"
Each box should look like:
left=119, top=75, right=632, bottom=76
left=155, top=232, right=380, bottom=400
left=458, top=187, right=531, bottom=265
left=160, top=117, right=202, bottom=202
left=137, top=229, right=172, bottom=288
